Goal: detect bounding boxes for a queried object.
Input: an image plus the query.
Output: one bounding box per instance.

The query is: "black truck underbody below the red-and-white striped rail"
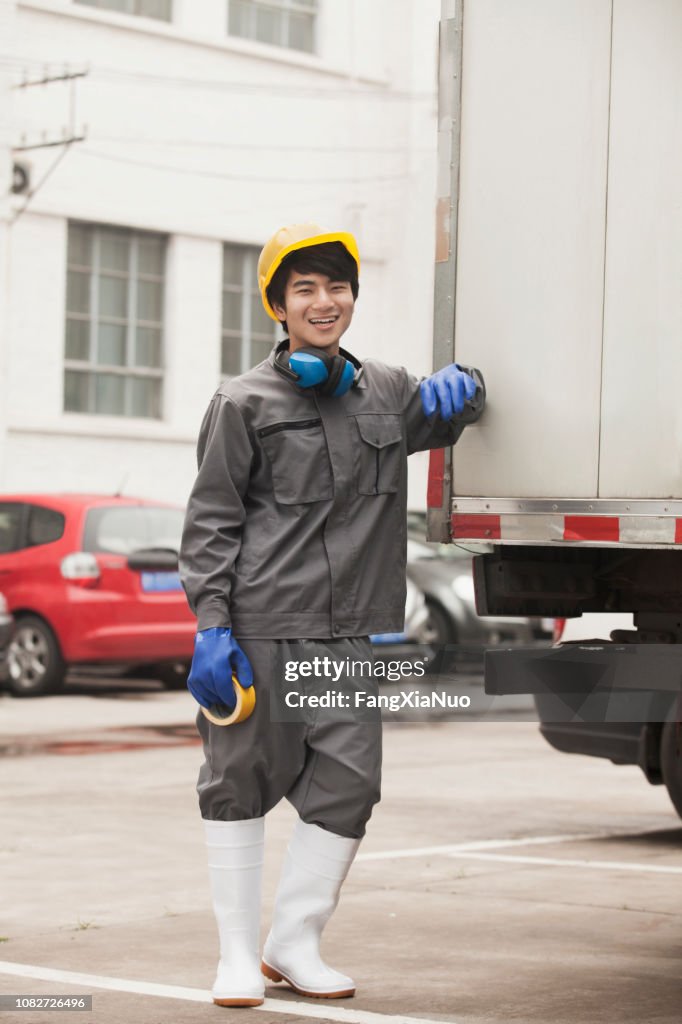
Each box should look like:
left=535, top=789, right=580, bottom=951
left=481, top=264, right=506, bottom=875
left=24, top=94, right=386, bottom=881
left=474, top=545, right=682, bottom=816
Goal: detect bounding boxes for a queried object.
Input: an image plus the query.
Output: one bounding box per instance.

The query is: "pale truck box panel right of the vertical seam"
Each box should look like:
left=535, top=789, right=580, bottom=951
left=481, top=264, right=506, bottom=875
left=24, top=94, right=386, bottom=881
left=599, top=0, right=682, bottom=498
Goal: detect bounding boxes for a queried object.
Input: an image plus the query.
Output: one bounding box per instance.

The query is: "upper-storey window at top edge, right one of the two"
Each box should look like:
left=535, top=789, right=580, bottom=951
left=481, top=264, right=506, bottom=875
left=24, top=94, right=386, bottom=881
left=227, top=0, right=317, bottom=53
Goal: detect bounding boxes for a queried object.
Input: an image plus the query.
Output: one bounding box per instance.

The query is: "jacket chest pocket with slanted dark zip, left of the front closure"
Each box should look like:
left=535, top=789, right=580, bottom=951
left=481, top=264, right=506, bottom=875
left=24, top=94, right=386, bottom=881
left=256, top=418, right=334, bottom=505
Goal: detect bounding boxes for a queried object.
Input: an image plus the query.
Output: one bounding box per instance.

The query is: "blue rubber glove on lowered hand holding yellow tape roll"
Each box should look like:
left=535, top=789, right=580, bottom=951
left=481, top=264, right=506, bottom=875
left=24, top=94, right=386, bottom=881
left=187, top=627, right=253, bottom=710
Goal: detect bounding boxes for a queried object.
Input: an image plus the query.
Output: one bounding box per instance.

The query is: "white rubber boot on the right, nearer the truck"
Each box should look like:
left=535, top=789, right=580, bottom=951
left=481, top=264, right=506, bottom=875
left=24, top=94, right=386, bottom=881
left=261, top=820, right=360, bottom=999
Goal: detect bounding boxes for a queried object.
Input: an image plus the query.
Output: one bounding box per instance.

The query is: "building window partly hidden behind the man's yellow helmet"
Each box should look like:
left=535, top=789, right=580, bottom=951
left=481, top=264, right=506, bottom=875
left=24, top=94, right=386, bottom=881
left=220, top=245, right=278, bottom=377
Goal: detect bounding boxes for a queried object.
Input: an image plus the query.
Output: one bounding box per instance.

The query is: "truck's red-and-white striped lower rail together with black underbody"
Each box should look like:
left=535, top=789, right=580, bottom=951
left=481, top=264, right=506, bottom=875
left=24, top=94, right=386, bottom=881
left=429, top=495, right=682, bottom=816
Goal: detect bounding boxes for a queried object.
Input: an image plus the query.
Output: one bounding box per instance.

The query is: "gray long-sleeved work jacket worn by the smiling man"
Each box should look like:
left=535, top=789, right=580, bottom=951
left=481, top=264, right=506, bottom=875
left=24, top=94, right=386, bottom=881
left=180, top=352, right=484, bottom=639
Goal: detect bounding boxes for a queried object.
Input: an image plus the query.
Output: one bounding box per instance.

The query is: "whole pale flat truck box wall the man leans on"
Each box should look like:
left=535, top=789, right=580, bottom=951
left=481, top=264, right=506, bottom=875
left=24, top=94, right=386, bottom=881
left=453, top=0, right=682, bottom=499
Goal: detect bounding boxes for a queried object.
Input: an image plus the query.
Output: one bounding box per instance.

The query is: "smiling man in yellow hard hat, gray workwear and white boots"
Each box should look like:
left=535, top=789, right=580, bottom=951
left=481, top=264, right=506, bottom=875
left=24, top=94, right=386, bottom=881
left=180, top=224, right=484, bottom=1006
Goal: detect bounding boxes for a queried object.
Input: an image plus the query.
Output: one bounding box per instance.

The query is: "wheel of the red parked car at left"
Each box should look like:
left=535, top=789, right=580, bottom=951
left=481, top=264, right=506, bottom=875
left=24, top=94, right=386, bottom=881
left=7, top=615, right=67, bottom=697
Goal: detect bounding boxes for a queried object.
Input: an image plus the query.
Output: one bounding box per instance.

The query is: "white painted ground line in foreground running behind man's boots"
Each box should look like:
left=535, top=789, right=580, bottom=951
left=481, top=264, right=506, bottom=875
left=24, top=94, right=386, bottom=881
left=0, top=961, right=454, bottom=1024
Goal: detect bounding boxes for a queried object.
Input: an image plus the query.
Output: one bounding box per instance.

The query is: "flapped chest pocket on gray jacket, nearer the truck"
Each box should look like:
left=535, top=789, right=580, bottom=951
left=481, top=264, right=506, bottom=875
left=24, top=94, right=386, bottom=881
left=355, top=413, right=402, bottom=495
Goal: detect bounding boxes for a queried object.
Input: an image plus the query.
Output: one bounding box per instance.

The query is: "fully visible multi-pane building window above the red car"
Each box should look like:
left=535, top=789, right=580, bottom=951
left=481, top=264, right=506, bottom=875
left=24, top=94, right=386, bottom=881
left=63, top=223, right=166, bottom=419
